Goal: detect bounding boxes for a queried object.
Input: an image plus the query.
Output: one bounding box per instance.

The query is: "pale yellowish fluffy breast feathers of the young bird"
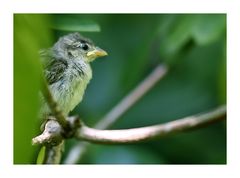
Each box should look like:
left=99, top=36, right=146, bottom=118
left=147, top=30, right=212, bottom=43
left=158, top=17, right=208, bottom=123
left=50, top=61, right=92, bottom=114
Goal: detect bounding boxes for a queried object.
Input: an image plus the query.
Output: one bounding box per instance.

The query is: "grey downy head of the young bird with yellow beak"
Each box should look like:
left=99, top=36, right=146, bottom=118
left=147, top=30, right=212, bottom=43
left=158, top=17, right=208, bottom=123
left=53, top=33, right=107, bottom=62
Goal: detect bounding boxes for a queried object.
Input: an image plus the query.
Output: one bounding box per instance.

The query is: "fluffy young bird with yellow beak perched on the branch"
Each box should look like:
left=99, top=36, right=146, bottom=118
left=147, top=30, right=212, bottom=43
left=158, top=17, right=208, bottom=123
left=39, top=32, right=107, bottom=118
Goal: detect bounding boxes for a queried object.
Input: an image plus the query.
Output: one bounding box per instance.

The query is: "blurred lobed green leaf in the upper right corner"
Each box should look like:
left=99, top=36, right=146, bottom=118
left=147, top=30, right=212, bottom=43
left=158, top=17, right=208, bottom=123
left=159, top=14, right=226, bottom=64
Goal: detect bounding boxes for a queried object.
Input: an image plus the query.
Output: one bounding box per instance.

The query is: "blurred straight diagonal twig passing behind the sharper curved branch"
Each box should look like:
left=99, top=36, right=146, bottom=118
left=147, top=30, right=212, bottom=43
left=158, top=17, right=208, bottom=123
left=64, top=64, right=168, bottom=164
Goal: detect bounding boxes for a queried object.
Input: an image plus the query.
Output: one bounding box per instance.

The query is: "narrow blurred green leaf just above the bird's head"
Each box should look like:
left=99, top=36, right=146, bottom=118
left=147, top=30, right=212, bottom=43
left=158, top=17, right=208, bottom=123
left=51, top=16, right=101, bottom=32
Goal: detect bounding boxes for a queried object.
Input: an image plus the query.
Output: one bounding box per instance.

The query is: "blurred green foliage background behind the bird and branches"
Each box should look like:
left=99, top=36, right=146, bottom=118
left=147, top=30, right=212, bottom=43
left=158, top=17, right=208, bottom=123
left=14, top=14, right=226, bottom=164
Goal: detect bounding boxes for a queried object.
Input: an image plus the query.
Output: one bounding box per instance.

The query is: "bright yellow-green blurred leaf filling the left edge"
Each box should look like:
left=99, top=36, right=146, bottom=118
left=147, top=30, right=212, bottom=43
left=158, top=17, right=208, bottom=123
left=14, top=14, right=50, bottom=164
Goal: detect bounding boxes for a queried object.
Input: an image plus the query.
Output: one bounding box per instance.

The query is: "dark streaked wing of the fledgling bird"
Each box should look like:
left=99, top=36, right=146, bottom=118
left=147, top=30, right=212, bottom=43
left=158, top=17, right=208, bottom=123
left=44, top=59, right=68, bottom=85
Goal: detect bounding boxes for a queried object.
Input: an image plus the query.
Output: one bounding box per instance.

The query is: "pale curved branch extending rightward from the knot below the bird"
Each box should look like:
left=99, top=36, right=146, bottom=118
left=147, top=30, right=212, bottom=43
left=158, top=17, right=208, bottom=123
left=75, top=106, right=226, bottom=144
